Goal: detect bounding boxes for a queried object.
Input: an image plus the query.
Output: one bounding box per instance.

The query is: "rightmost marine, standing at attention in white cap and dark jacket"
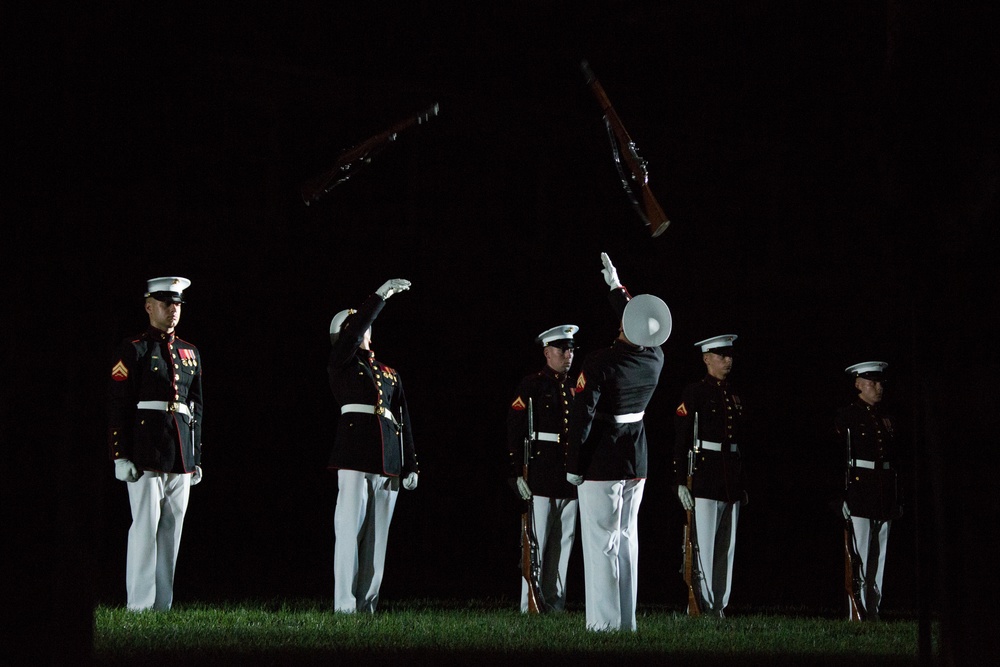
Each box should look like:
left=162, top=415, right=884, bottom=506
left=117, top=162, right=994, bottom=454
left=834, top=361, right=902, bottom=620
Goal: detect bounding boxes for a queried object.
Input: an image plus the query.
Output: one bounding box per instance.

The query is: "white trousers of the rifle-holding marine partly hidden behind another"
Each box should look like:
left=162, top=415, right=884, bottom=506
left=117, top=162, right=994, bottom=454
left=521, top=496, right=579, bottom=612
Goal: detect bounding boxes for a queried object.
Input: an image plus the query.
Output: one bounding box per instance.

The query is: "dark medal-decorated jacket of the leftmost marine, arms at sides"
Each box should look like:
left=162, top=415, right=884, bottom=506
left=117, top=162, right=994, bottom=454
left=108, top=327, right=202, bottom=473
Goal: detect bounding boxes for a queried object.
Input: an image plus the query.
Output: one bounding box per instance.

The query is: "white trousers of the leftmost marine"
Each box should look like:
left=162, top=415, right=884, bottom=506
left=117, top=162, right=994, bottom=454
left=125, top=470, right=191, bottom=611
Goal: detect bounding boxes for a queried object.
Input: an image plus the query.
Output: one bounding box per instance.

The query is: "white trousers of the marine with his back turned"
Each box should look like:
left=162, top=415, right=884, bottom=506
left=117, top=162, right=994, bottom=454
left=578, top=479, right=646, bottom=631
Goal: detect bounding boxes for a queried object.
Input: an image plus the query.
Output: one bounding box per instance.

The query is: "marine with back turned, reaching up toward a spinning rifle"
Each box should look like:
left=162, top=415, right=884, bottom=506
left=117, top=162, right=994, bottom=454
left=566, top=253, right=671, bottom=631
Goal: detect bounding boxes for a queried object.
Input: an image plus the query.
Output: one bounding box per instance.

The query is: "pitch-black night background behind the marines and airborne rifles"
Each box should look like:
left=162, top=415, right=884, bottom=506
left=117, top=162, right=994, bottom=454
left=7, top=0, right=1000, bottom=664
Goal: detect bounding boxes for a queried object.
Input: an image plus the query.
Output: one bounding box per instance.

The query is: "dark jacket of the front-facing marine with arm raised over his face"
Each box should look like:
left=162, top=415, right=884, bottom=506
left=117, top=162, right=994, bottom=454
left=327, top=294, right=419, bottom=477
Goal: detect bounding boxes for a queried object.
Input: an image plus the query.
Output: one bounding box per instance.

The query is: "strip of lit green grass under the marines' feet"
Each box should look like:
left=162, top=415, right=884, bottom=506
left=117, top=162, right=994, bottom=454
left=94, top=601, right=932, bottom=667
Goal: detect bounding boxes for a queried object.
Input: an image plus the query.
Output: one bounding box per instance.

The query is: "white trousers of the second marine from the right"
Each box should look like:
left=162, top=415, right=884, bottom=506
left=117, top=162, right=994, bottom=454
left=694, top=498, right=740, bottom=612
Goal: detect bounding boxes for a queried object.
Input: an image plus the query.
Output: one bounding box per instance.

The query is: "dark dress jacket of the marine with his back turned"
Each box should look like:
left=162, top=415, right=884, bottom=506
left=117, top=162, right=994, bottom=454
left=566, top=287, right=663, bottom=481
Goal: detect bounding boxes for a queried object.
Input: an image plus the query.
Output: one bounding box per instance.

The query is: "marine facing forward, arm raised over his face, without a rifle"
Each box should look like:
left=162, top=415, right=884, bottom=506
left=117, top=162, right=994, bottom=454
left=327, top=279, right=418, bottom=613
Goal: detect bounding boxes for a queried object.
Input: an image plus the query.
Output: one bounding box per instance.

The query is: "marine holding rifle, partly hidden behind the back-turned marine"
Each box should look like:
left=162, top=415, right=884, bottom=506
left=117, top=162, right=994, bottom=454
left=507, top=324, right=580, bottom=612
